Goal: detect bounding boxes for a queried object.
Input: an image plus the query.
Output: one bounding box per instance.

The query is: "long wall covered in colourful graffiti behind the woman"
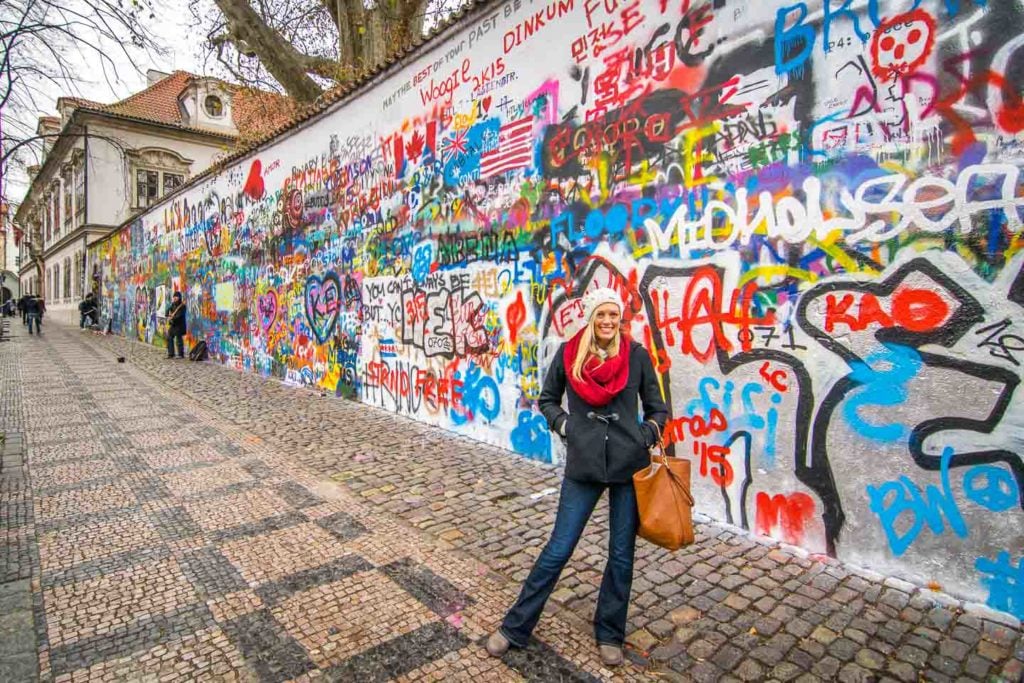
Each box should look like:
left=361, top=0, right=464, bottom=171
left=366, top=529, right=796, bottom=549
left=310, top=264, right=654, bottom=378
left=92, top=0, right=1024, bottom=617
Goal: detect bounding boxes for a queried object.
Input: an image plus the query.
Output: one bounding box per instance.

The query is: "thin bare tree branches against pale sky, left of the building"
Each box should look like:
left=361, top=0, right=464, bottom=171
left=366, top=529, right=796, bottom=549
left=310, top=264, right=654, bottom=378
left=0, top=0, right=162, bottom=198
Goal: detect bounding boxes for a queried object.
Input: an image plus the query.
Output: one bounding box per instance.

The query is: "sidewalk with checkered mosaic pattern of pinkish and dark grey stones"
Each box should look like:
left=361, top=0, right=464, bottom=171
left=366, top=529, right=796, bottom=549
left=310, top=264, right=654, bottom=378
left=0, top=325, right=645, bottom=682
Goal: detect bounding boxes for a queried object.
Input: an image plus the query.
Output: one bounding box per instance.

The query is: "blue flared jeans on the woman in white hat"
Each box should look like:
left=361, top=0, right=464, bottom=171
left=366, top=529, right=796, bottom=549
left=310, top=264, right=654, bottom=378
left=501, top=478, right=640, bottom=647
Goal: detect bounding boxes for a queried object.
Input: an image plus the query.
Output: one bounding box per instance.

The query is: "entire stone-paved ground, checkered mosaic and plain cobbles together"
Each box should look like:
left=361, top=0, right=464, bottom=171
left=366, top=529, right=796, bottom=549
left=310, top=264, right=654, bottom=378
left=0, top=326, right=1024, bottom=682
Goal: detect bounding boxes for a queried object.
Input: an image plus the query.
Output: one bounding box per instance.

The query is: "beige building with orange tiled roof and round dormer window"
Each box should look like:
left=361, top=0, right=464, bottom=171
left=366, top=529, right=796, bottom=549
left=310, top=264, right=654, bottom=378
left=14, top=71, right=291, bottom=323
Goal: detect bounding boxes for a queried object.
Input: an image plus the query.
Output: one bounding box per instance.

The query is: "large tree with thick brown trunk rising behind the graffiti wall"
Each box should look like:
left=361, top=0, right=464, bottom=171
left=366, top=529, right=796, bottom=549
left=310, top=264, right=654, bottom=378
left=189, top=0, right=467, bottom=102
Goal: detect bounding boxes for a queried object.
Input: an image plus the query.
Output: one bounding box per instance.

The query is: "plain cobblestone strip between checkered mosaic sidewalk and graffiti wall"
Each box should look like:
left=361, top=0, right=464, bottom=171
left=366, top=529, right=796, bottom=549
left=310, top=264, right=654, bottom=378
left=77, top=325, right=1024, bottom=683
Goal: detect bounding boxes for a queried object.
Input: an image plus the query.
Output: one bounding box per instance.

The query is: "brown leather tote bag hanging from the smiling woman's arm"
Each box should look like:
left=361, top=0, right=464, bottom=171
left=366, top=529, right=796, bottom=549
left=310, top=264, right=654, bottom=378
left=633, top=423, right=693, bottom=550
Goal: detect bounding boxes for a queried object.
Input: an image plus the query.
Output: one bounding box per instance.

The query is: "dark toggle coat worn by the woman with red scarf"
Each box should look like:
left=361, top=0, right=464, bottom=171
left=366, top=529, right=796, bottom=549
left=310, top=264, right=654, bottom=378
left=539, top=341, right=669, bottom=483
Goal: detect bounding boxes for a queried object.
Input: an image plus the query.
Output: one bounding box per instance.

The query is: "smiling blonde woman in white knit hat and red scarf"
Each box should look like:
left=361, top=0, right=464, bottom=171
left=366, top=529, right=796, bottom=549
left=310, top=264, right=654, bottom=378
left=486, top=288, right=669, bottom=667
